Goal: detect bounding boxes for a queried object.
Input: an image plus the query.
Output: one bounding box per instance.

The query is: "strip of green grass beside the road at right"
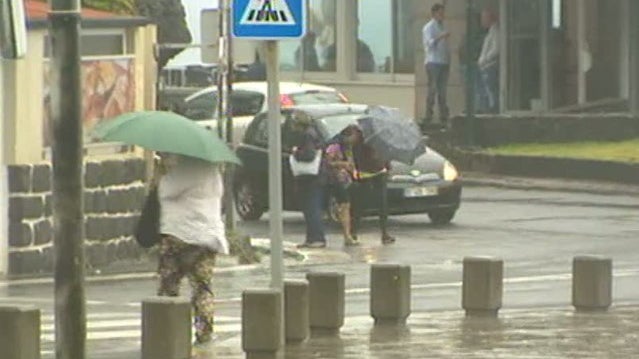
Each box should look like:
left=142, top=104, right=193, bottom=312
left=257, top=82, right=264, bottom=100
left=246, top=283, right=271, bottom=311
left=488, top=139, right=639, bottom=162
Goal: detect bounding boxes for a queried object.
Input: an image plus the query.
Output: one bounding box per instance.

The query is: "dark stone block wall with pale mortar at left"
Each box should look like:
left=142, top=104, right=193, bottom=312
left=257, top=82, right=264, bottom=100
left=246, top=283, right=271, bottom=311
left=8, top=158, right=146, bottom=276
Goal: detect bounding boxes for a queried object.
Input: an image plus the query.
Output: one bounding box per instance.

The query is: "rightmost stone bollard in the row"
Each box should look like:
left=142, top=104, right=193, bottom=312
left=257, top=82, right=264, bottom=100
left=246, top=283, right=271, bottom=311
left=572, top=256, right=612, bottom=311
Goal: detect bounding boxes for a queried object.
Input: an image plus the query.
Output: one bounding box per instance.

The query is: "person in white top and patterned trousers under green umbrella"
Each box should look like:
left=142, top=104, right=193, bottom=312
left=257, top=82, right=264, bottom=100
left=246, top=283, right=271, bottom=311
left=158, top=154, right=229, bottom=344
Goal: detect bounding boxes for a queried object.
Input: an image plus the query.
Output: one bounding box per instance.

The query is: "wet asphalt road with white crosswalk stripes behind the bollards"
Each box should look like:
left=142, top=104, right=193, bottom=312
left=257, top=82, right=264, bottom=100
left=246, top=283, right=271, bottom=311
left=0, top=187, right=639, bottom=358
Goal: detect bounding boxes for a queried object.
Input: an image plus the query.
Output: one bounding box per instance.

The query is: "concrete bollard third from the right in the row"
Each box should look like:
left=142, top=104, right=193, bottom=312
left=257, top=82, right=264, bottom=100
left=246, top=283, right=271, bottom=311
left=370, top=264, right=410, bottom=324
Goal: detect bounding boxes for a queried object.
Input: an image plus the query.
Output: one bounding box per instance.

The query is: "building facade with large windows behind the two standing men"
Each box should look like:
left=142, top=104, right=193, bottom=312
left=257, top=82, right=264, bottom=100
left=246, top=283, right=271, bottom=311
left=270, top=0, right=639, bottom=117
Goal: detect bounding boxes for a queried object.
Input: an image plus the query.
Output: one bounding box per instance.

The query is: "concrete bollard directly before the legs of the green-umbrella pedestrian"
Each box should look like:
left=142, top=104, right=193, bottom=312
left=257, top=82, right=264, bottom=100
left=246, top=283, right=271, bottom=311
left=142, top=297, right=192, bottom=359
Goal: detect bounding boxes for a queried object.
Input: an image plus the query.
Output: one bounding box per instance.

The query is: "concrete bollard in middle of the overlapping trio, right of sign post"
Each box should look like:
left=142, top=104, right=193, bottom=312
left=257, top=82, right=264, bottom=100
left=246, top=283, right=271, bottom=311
left=284, top=281, right=310, bottom=343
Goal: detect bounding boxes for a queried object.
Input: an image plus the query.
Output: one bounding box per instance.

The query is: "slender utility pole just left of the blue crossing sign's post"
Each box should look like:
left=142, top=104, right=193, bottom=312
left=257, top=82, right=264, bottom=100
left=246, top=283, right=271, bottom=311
left=217, top=0, right=236, bottom=233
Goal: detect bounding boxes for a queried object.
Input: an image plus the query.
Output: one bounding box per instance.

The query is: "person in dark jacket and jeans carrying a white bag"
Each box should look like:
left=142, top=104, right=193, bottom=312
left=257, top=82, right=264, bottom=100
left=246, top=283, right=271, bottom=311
left=293, top=112, right=327, bottom=248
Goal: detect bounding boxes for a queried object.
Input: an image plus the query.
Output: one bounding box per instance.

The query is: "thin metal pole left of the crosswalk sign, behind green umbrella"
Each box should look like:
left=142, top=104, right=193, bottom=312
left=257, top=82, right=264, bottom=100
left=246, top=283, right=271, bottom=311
left=220, top=0, right=236, bottom=233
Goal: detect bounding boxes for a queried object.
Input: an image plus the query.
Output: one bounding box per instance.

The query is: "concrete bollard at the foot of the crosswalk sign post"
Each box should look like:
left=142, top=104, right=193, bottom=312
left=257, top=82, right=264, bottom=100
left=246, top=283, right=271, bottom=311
left=242, top=289, right=284, bottom=359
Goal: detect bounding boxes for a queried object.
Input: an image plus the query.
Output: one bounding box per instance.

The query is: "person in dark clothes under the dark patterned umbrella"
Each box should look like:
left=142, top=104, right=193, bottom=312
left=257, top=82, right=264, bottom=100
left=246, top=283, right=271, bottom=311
left=351, top=131, right=395, bottom=244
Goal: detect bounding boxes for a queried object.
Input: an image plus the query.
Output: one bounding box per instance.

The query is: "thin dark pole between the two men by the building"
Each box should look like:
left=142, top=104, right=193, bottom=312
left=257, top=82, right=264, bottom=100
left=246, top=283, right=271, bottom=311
left=464, top=0, right=477, bottom=147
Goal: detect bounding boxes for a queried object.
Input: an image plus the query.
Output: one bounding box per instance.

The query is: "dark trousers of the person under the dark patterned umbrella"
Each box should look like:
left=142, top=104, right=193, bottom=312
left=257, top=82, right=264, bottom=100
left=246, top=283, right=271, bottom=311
left=351, top=174, right=388, bottom=239
